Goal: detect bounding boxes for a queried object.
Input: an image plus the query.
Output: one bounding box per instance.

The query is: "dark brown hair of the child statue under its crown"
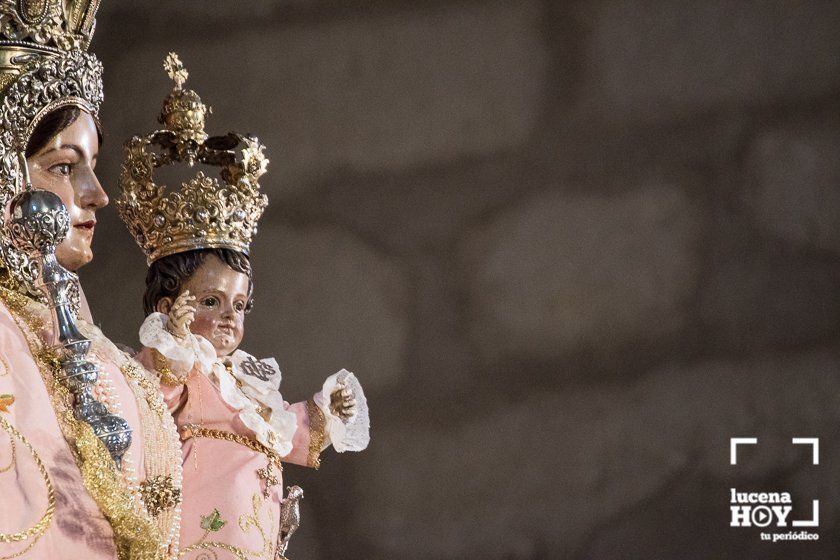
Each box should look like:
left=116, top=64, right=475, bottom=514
left=143, top=249, right=254, bottom=315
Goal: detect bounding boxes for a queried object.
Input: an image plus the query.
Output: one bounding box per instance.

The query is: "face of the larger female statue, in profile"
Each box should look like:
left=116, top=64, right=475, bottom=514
left=26, top=111, right=108, bottom=271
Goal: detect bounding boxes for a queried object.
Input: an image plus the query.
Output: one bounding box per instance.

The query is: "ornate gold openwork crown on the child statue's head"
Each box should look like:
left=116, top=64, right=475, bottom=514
left=117, top=53, right=268, bottom=264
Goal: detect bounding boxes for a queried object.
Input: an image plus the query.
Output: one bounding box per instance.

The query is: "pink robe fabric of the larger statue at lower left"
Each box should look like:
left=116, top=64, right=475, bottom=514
left=0, top=303, right=145, bottom=560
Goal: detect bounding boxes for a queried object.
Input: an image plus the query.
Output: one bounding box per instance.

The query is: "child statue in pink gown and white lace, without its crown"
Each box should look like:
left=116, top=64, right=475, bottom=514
left=139, top=248, right=369, bottom=558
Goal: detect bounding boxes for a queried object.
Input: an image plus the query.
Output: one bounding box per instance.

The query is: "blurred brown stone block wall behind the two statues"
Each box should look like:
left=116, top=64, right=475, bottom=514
left=82, top=0, right=840, bottom=560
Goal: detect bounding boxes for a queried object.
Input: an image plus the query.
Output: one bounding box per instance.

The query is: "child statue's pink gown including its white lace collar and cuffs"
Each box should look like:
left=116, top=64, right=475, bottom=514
left=138, top=313, right=369, bottom=559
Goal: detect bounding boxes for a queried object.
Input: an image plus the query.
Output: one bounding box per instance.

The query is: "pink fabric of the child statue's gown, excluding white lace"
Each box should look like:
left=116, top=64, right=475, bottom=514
left=137, top=348, right=320, bottom=560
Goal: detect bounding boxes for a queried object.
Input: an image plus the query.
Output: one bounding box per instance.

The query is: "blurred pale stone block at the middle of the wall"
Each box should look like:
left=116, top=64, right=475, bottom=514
left=462, top=187, right=699, bottom=366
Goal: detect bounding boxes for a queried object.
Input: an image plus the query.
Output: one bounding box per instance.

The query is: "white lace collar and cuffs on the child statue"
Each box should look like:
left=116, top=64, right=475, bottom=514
left=140, top=313, right=370, bottom=457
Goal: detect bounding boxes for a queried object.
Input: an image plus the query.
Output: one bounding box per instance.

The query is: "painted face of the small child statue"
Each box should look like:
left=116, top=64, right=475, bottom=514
left=182, top=255, right=248, bottom=356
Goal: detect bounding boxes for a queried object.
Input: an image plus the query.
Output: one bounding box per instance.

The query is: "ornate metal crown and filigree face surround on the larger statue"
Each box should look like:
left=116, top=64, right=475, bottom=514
left=0, top=0, right=102, bottom=298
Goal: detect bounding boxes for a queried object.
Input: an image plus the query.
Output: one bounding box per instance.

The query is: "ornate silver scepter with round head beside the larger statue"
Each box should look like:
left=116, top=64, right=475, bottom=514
left=9, top=190, right=131, bottom=468
